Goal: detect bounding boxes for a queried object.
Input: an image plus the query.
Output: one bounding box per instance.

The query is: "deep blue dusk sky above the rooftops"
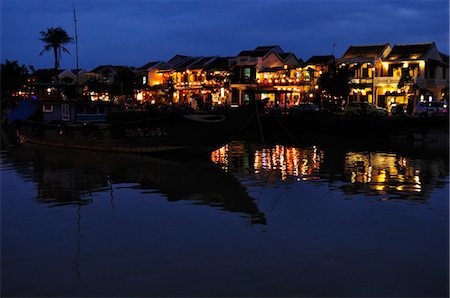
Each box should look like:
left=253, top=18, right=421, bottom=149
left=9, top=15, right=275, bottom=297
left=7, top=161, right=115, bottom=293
left=0, top=0, right=449, bottom=69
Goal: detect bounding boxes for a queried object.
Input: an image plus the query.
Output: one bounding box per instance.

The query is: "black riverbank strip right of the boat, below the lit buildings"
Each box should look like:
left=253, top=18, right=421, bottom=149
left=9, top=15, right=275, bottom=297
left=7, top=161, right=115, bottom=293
left=239, top=115, right=449, bottom=154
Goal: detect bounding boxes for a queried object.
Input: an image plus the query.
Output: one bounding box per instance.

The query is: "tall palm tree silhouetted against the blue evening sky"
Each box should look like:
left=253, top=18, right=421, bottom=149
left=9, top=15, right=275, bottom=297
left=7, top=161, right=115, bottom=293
left=39, top=27, right=73, bottom=80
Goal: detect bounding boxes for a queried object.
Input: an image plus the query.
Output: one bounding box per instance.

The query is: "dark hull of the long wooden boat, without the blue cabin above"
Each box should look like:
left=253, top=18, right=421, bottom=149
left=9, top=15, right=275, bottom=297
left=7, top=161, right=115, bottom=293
left=16, top=107, right=255, bottom=153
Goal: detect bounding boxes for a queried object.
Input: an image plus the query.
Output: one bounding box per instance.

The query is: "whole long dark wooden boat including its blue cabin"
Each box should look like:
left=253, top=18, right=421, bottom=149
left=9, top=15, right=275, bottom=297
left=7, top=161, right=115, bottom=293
left=9, top=97, right=259, bottom=153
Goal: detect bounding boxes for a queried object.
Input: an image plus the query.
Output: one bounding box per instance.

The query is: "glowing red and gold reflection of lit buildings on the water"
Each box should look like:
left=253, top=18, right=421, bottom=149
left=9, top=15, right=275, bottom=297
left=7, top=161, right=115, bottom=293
left=211, top=142, right=448, bottom=200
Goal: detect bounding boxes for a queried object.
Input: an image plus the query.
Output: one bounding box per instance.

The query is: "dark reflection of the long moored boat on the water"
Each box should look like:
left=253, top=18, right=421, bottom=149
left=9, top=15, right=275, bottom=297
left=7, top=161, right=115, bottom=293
left=2, top=145, right=266, bottom=224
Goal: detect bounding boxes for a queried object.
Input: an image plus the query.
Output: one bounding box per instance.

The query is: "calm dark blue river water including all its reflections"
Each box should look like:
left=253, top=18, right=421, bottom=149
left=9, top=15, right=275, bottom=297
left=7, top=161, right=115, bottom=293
left=1, top=142, right=449, bottom=297
